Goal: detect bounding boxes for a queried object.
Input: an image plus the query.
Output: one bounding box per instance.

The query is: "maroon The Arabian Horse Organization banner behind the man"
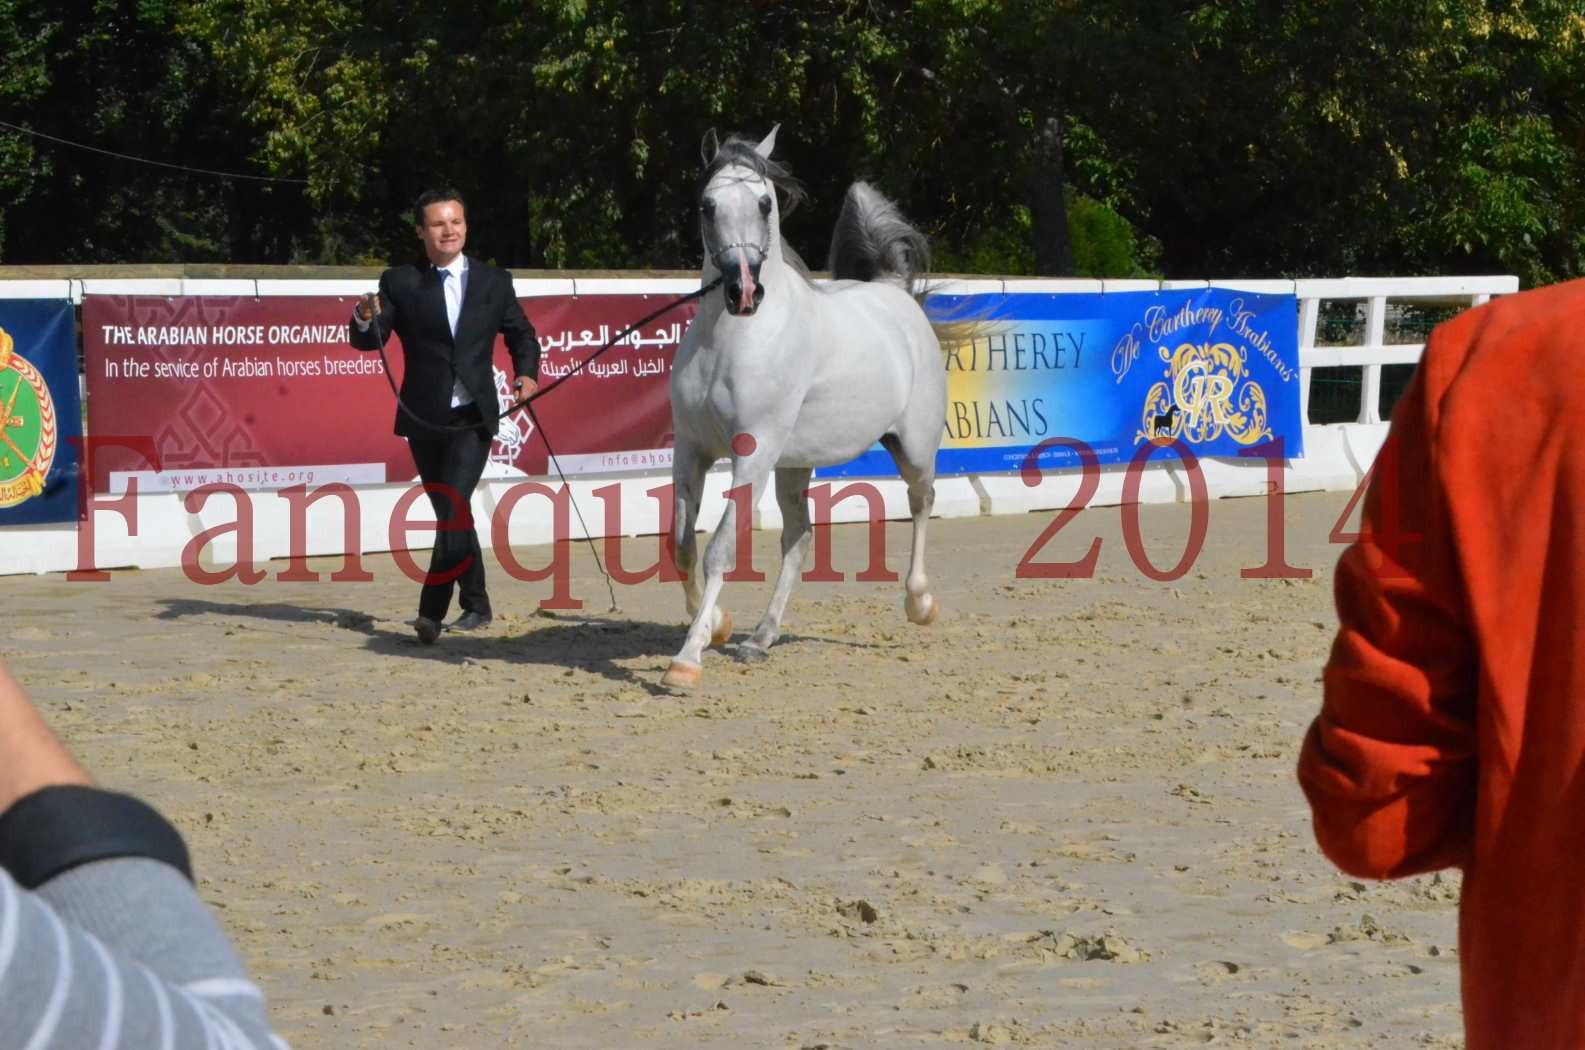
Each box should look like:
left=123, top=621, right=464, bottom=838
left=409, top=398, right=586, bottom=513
left=82, top=295, right=694, bottom=493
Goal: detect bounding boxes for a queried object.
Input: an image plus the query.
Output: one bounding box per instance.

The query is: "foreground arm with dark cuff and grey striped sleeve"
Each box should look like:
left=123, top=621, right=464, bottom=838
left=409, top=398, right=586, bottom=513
left=0, top=665, right=285, bottom=1050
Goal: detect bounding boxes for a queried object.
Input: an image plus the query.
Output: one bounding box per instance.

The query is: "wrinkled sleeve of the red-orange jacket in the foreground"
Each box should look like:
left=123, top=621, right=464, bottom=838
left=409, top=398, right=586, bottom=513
left=1298, top=345, right=1477, bottom=879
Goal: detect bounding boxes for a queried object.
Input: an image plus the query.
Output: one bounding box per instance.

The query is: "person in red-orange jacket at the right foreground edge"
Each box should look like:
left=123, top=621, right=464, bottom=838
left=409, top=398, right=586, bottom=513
left=1298, top=281, right=1585, bottom=1050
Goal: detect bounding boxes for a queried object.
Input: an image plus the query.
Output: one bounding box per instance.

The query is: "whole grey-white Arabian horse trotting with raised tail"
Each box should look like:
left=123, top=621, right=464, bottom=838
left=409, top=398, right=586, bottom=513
left=663, top=125, right=946, bottom=687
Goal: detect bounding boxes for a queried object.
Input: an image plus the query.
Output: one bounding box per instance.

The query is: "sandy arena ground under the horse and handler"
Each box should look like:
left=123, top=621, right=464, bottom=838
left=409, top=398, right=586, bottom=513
left=0, top=493, right=1461, bottom=1050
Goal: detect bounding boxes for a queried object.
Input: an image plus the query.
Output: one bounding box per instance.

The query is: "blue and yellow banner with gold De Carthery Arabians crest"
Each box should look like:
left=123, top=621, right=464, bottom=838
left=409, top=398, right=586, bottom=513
left=816, top=289, right=1304, bottom=477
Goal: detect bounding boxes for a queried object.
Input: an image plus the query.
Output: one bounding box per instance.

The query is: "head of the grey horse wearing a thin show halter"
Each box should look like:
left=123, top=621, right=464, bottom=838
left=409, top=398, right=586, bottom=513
left=699, top=125, right=797, bottom=316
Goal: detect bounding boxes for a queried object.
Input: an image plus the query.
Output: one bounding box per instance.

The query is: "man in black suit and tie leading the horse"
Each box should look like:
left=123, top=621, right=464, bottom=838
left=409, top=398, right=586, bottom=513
left=347, top=189, right=539, bottom=646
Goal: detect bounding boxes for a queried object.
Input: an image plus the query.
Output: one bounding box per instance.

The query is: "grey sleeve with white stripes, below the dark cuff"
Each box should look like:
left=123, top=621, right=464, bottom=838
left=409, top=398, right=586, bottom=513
left=0, top=858, right=285, bottom=1050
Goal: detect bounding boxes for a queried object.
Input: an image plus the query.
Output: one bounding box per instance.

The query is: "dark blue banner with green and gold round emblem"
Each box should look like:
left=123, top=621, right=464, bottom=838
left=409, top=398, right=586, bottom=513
left=0, top=298, right=82, bottom=525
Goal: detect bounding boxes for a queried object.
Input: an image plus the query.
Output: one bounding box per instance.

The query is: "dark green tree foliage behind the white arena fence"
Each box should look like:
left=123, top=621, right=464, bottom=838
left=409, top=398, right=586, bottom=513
left=0, top=0, right=1585, bottom=284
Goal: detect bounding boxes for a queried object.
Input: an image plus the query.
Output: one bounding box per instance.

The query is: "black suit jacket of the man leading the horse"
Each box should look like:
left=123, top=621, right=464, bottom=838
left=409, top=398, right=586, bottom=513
left=347, top=257, right=539, bottom=436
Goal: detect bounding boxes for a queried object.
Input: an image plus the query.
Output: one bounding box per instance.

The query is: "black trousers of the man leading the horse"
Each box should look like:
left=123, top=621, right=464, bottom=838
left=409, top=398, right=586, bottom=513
left=407, top=404, right=495, bottom=623
